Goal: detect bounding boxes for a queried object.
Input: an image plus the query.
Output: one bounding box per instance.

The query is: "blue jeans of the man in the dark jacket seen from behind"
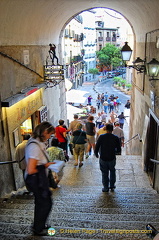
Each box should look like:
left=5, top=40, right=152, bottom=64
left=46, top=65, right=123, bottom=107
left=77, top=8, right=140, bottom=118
left=99, top=159, right=116, bottom=189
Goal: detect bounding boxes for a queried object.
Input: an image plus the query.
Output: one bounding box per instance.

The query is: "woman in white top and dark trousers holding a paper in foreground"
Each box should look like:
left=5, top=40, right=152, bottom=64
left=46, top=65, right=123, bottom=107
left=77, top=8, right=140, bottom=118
left=25, top=122, right=55, bottom=236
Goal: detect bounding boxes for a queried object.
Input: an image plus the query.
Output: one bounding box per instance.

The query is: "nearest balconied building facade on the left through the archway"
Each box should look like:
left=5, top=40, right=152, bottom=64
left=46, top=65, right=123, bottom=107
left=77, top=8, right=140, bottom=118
left=62, top=15, right=84, bottom=89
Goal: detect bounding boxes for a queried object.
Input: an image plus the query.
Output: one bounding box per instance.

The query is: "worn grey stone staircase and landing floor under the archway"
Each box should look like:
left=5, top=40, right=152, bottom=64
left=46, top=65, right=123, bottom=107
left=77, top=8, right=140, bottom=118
left=0, top=155, right=159, bottom=240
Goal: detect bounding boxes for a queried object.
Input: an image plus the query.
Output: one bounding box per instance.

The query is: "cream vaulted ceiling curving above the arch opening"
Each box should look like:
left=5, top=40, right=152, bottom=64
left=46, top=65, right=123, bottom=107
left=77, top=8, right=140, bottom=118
left=0, top=0, right=159, bottom=45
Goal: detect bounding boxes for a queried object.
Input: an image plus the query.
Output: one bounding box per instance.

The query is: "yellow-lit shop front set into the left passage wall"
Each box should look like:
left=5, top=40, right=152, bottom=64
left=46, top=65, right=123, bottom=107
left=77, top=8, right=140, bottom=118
left=2, top=85, right=47, bottom=188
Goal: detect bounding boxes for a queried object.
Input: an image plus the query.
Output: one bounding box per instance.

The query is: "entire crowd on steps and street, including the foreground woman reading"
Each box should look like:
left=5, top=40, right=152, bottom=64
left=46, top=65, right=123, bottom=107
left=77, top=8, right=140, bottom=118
left=15, top=89, right=130, bottom=236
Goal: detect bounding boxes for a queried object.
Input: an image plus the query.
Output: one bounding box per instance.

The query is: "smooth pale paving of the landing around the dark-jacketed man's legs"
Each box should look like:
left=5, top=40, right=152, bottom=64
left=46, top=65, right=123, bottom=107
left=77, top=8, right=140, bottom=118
left=61, top=155, right=151, bottom=188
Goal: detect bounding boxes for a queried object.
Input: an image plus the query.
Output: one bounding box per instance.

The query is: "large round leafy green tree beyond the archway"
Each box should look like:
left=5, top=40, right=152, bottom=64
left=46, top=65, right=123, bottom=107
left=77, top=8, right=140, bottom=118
left=96, top=43, right=122, bottom=68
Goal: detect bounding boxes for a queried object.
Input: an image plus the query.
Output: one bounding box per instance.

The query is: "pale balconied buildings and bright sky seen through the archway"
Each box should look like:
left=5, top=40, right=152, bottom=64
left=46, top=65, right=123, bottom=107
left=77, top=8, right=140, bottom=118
left=63, top=9, right=133, bottom=89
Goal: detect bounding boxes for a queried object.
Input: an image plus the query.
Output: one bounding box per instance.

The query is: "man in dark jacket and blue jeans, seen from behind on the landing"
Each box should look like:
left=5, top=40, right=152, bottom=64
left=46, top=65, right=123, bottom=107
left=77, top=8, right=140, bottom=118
left=94, top=124, right=121, bottom=192
